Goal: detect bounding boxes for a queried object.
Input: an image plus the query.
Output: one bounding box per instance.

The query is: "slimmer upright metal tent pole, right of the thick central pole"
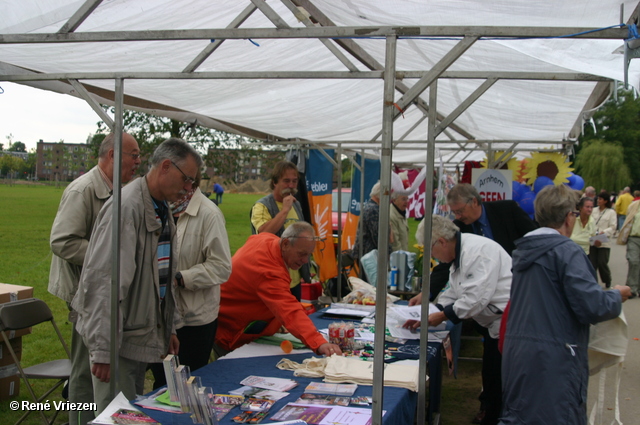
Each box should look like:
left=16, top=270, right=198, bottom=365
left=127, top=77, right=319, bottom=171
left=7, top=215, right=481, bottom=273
left=417, top=80, right=441, bottom=424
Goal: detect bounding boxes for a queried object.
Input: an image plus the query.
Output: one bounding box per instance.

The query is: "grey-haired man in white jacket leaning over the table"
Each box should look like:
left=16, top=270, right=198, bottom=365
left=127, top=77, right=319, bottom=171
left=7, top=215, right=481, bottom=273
left=404, top=215, right=511, bottom=425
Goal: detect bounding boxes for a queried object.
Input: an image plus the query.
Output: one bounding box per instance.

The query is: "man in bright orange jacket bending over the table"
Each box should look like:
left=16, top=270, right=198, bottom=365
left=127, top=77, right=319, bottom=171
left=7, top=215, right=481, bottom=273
left=215, top=221, right=342, bottom=356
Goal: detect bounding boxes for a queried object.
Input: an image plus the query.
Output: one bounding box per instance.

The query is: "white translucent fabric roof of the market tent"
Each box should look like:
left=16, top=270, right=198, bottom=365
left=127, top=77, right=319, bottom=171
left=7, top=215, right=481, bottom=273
left=0, top=0, right=640, bottom=163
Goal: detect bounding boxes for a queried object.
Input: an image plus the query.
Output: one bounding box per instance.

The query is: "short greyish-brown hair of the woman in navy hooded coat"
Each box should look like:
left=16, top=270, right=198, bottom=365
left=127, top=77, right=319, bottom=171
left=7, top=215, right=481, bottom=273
left=534, top=184, right=580, bottom=229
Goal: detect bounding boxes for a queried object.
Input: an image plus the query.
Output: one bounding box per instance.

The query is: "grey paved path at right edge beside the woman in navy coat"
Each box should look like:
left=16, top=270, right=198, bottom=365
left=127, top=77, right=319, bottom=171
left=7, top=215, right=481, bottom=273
left=588, top=240, right=640, bottom=425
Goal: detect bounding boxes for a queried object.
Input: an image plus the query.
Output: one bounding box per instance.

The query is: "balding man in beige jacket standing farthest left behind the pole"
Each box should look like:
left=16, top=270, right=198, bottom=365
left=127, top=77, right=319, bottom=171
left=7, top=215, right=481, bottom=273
left=49, top=133, right=140, bottom=425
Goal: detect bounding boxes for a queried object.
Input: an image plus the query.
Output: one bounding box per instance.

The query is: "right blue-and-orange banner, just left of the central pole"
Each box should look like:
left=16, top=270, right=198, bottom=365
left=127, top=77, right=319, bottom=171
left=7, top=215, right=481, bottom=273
left=342, top=154, right=380, bottom=251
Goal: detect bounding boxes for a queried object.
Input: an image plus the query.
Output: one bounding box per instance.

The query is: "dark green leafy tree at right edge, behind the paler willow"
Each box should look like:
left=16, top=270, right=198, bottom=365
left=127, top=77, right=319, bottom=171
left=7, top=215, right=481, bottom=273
left=576, top=88, right=640, bottom=190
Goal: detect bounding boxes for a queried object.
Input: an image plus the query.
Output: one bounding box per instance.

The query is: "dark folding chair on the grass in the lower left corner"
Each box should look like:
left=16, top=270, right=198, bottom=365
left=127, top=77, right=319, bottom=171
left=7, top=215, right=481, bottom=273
left=0, top=298, right=71, bottom=425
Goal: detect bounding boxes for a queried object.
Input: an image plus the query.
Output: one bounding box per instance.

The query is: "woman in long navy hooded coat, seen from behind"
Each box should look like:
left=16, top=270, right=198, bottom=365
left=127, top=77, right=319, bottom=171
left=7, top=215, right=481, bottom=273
left=500, top=185, right=631, bottom=425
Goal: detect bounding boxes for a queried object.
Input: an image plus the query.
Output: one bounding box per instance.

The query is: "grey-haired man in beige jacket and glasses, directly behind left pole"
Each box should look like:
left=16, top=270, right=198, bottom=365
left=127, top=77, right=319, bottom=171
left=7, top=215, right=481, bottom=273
left=72, top=139, right=202, bottom=412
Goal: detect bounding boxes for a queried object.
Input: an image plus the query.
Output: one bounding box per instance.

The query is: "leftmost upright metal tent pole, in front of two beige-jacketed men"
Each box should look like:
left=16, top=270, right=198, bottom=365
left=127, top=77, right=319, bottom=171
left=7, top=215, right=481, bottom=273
left=109, top=79, right=124, bottom=398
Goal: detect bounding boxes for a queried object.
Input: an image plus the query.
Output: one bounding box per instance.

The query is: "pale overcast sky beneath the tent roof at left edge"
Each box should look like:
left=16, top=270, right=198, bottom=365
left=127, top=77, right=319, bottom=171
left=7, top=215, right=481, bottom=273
left=0, top=82, right=100, bottom=151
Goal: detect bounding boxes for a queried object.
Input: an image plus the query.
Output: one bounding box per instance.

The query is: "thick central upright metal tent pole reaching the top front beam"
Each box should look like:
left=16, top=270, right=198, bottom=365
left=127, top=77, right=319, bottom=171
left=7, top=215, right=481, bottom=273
left=370, top=36, right=397, bottom=425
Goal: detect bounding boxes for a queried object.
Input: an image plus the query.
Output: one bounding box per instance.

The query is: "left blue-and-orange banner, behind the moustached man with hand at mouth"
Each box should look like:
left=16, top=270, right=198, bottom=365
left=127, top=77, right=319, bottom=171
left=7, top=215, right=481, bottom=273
left=306, top=149, right=338, bottom=282
